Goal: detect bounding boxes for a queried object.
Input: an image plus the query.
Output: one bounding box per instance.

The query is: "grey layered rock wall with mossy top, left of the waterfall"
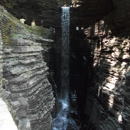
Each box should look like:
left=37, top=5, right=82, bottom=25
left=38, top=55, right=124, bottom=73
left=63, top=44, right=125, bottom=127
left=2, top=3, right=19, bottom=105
left=0, top=7, right=55, bottom=130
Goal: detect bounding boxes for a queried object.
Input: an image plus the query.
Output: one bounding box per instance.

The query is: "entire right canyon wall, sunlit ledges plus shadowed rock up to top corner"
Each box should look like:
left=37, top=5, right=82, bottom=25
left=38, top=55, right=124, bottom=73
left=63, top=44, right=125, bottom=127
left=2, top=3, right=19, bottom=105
left=82, top=1, right=130, bottom=130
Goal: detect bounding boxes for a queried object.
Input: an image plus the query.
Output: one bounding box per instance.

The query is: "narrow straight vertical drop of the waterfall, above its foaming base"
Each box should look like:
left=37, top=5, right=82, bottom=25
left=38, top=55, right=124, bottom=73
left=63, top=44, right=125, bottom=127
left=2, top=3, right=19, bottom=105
left=61, top=7, right=70, bottom=102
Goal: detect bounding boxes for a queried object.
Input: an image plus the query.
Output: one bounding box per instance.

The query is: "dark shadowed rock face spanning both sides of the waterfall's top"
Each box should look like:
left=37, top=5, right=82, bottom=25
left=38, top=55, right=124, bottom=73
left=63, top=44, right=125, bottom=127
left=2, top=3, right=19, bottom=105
left=1, top=0, right=114, bottom=31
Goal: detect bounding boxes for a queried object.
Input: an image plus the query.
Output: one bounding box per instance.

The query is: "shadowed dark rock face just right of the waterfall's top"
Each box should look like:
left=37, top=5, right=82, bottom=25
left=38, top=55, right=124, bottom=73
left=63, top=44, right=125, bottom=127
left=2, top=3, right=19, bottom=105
left=71, top=0, right=114, bottom=29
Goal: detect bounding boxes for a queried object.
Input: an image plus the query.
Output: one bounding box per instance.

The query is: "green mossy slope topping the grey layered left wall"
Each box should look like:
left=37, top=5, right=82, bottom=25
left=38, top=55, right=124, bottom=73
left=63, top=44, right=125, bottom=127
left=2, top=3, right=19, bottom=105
left=0, top=4, right=51, bottom=45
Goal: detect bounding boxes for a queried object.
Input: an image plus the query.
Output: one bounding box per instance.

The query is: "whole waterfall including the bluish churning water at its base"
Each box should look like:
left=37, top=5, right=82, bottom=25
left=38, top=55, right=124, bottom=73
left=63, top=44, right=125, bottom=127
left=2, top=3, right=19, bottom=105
left=52, top=7, right=70, bottom=130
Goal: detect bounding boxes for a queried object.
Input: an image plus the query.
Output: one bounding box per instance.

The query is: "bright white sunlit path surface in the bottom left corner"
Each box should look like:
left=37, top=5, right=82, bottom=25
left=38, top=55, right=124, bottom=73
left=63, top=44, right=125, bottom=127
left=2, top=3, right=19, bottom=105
left=0, top=98, right=18, bottom=130
